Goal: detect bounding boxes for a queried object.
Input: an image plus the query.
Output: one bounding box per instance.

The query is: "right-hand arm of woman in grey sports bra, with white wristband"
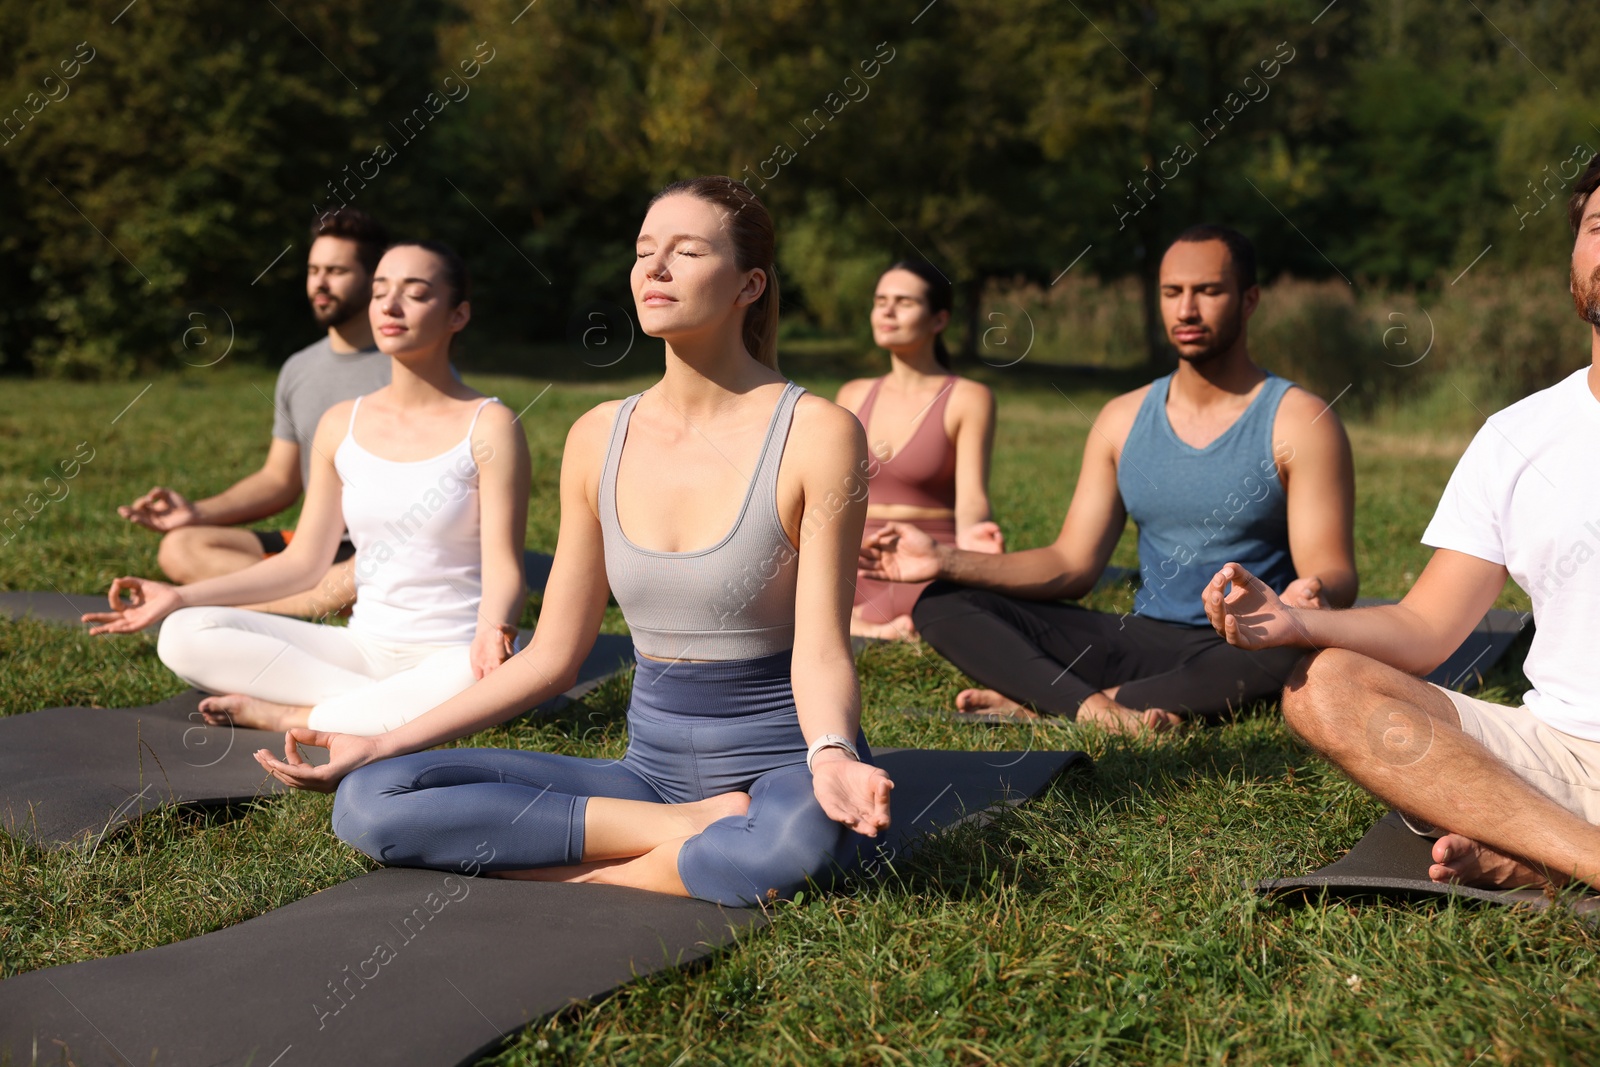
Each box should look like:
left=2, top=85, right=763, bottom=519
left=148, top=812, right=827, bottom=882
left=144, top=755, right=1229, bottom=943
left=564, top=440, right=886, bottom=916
left=779, top=397, right=893, bottom=837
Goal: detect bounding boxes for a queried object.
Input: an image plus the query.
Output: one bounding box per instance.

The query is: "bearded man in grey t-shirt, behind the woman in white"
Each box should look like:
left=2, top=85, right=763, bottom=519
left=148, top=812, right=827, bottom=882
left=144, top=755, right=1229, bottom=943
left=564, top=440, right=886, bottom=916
left=117, top=208, right=390, bottom=617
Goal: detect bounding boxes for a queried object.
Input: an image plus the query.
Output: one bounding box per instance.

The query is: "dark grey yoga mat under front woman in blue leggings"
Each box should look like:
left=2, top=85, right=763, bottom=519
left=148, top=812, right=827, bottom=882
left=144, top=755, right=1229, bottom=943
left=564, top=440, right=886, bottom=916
left=0, top=750, right=1083, bottom=1067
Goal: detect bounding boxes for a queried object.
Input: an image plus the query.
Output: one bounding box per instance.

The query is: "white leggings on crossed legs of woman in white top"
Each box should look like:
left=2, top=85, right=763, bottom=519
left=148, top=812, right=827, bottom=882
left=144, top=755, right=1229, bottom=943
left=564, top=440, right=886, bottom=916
left=157, top=608, right=474, bottom=736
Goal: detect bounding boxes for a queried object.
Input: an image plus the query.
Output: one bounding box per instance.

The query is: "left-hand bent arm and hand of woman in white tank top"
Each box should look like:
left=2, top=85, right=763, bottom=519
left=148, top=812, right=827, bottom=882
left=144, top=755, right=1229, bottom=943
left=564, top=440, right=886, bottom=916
left=83, top=402, right=350, bottom=633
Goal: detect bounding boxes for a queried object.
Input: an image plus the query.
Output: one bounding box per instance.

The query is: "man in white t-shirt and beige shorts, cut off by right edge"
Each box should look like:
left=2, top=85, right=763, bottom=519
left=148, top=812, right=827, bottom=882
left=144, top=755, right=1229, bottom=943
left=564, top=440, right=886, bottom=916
left=1203, top=155, right=1600, bottom=888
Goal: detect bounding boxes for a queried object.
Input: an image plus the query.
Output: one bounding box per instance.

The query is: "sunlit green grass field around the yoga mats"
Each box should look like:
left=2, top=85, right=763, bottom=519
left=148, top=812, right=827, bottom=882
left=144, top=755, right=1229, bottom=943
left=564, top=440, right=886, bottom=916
left=0, top=358, right=1600, bottom=1067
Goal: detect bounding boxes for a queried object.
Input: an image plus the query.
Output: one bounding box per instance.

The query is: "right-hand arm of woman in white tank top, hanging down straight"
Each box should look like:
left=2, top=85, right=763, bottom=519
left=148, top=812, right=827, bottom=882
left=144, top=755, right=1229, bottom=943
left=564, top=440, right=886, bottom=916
left=472, top=403, right=531, bottom=678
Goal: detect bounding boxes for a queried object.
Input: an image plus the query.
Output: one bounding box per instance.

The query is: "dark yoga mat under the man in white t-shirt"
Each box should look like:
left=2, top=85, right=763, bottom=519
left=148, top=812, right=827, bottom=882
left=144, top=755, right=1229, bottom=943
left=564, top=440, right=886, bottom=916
left=1254, top=811, right=1600, bottom=918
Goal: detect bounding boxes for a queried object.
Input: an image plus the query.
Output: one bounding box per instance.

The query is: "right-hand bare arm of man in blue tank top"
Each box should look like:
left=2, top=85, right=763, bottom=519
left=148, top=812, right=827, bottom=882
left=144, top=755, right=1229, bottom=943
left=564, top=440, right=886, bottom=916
left=1272, top=389, right=1360, bottom=608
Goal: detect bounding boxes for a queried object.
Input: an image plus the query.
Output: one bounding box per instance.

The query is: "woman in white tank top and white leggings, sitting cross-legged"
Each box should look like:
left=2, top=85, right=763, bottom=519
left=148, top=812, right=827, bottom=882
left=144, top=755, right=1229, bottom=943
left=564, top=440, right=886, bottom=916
left=85, top=243, right=530, bottom=734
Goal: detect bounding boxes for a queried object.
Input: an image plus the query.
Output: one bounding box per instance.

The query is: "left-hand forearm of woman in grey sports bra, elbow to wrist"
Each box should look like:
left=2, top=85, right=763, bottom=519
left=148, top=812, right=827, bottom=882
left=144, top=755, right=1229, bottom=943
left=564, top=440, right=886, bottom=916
left=376, top=645, right=578, bottom=758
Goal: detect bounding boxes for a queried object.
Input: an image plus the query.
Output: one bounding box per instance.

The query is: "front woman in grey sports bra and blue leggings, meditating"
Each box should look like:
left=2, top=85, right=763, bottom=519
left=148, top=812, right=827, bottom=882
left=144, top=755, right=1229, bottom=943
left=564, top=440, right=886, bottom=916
left=256, top=178, right=893, bottom=905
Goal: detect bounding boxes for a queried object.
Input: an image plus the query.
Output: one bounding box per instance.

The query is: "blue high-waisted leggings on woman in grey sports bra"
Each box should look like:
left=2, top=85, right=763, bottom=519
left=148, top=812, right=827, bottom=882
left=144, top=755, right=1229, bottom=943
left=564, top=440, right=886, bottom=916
left=333, top=649, right=870, bottom=907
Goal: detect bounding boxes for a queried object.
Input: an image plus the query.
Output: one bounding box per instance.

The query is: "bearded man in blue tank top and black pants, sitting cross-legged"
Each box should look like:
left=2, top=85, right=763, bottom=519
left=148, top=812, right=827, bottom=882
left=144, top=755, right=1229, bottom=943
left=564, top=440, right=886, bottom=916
left=861, top=226, right=1357, bottom=731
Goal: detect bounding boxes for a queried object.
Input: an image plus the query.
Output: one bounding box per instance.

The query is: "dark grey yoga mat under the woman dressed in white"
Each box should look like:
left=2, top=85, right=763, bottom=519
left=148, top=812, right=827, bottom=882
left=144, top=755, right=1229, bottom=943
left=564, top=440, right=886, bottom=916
left=0, top=633, right=634, bottom=848
